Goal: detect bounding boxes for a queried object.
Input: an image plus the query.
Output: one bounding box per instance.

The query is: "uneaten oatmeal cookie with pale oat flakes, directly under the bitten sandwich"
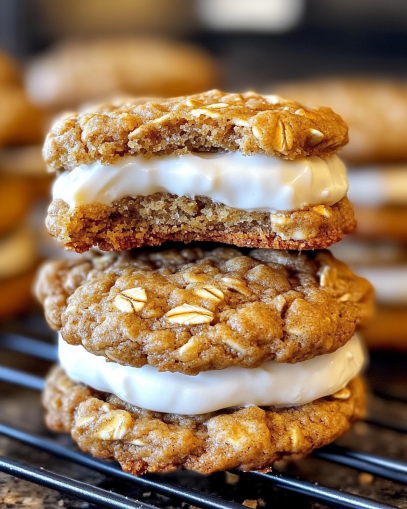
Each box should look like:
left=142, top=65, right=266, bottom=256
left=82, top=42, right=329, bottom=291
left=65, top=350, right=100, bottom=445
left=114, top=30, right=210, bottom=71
left=36, top=247, right=373, bottom=375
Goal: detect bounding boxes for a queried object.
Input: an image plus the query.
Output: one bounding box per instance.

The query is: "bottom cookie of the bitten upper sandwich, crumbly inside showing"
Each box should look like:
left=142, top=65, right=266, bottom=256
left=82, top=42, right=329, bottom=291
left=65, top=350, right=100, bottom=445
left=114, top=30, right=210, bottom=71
left=46, top=193, right=356, bottom=253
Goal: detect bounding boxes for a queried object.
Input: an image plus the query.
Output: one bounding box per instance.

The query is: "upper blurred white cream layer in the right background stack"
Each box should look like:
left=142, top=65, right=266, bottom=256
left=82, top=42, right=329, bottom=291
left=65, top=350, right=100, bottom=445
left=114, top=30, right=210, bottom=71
left=348, top=165, right=407, bottom=206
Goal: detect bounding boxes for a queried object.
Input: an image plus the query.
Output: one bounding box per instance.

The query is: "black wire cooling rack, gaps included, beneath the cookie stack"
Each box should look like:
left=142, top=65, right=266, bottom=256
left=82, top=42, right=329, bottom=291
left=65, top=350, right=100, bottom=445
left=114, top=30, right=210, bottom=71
left=0, top=315, right=407, bottom=509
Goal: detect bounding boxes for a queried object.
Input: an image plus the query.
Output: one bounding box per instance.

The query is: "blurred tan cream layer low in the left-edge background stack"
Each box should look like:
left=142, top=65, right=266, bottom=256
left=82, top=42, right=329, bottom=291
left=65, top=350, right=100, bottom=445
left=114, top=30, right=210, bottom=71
left=0, top=225, right=36, bottom=279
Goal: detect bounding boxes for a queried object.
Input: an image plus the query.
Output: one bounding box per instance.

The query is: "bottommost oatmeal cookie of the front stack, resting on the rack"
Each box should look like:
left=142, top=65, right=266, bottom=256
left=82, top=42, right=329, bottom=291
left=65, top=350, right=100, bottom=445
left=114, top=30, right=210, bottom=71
left=43, top=367, right=365, bottom=475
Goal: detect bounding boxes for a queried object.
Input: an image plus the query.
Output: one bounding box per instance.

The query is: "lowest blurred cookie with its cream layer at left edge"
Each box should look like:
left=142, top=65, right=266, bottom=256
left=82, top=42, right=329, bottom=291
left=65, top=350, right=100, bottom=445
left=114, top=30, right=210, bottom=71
left=0, top=224, right=38, bottom=319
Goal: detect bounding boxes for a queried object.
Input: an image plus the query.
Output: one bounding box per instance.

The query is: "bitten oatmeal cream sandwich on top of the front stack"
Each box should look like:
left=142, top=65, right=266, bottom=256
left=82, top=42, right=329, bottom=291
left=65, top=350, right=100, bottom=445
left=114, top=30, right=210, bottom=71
left=43, top=90, right=355, bottom=252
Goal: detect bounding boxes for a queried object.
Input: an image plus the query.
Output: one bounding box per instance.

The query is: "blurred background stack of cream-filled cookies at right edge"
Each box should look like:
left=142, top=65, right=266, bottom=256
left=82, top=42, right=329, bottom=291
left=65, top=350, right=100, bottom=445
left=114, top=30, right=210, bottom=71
left=281, top=79, right=407, bottom=349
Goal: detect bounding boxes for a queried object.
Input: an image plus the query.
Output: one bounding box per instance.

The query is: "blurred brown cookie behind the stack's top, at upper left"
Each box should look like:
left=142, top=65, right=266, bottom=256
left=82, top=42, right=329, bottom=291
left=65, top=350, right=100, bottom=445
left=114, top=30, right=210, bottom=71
left=26, top=37, right=219, bottom=110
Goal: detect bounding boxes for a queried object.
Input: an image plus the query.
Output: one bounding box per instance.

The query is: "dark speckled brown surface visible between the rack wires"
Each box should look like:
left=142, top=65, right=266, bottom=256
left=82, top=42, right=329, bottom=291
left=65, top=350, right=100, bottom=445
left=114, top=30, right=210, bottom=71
left=0, top=317, right=407, bottom=509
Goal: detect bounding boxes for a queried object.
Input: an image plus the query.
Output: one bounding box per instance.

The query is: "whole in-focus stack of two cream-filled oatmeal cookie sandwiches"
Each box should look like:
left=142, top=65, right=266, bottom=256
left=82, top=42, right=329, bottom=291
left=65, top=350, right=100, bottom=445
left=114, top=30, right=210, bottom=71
left=37, top=90, right=372, bottom=475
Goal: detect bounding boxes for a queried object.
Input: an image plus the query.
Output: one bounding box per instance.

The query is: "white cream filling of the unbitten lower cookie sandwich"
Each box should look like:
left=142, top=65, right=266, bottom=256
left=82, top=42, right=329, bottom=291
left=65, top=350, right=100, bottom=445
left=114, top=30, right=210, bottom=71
left=59, top=335, right=366, bottom=415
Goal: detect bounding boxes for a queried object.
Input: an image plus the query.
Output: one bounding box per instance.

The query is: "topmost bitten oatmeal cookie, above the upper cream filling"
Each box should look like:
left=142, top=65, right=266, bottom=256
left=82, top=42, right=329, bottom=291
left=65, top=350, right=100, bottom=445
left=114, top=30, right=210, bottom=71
left=43, top=90, right=348, bottom=170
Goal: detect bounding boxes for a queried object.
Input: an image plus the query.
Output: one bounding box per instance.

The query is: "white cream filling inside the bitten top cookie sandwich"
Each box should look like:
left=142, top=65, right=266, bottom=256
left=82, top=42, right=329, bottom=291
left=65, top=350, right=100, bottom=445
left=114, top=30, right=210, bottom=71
left=53, top=151, right=348, bottom=212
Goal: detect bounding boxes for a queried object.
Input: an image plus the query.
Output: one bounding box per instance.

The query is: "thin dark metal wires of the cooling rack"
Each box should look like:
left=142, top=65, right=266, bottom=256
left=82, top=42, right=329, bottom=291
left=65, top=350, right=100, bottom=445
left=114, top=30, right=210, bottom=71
left=0, top=324, right=407, bottom=509
